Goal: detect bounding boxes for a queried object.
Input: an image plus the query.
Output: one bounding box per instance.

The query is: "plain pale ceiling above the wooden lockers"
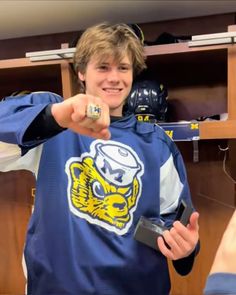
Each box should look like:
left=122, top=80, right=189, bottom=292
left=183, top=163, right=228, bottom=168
left=0, top=0, right=236, bottom=39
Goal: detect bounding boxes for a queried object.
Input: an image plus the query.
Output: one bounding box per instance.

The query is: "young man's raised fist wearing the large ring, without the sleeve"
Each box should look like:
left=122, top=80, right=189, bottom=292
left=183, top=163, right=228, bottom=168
left=51, top=94, right=111, bottom=139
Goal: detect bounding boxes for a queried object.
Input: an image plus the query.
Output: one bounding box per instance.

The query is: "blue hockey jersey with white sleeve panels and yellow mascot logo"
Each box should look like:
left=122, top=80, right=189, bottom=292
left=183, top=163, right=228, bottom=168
left=0, top=92, right=195, bottom=295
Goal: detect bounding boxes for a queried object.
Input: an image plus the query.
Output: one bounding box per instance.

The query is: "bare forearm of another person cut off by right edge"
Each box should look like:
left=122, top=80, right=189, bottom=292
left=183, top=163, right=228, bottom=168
left=210, top=211, right=236, bottom=273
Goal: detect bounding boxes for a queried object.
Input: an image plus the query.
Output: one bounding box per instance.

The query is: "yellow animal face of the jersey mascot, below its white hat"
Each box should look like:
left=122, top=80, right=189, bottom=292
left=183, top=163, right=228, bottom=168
left=67, top=141, right=145, bottom=234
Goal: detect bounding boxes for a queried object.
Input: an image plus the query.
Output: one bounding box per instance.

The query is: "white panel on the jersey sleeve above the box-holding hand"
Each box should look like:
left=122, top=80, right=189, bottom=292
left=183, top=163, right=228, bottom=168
left=160, top=155, right=183, bottom=215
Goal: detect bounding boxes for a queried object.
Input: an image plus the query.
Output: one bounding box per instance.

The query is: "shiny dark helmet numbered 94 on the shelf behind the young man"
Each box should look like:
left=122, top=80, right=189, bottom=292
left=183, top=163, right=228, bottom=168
left=126, top=80, right=168, bottom=122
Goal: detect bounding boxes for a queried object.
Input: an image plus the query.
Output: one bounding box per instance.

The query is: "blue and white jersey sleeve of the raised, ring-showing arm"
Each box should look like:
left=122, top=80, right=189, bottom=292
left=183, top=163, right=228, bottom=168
left=0, top=92, right=62, bottom=174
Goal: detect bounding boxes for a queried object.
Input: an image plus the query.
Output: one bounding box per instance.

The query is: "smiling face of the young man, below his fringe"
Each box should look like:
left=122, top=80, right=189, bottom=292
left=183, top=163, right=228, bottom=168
left=79, top=55, right=133, bottom=116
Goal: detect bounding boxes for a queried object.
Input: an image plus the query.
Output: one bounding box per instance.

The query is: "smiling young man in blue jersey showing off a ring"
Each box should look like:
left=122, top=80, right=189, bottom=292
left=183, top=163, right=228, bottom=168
left=0, top=23, right=199, bottom=295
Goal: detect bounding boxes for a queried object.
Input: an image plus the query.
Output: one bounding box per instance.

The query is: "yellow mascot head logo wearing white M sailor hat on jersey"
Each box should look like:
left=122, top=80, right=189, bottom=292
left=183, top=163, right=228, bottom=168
left=66, top=140, right=144, bottom=235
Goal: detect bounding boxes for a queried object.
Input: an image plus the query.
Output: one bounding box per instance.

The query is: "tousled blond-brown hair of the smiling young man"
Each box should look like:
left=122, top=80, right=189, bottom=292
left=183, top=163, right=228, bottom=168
left=74, top=23, right=146, bottom=92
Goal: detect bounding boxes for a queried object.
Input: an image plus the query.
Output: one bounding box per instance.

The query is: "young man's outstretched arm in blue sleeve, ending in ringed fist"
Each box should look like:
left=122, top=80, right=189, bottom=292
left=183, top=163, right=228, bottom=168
left=0, top=92, right=110, bottom=148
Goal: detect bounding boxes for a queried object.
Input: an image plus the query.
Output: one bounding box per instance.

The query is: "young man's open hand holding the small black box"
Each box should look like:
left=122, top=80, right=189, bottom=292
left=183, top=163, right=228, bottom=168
left=157, top=212, right=199, bottom=260
